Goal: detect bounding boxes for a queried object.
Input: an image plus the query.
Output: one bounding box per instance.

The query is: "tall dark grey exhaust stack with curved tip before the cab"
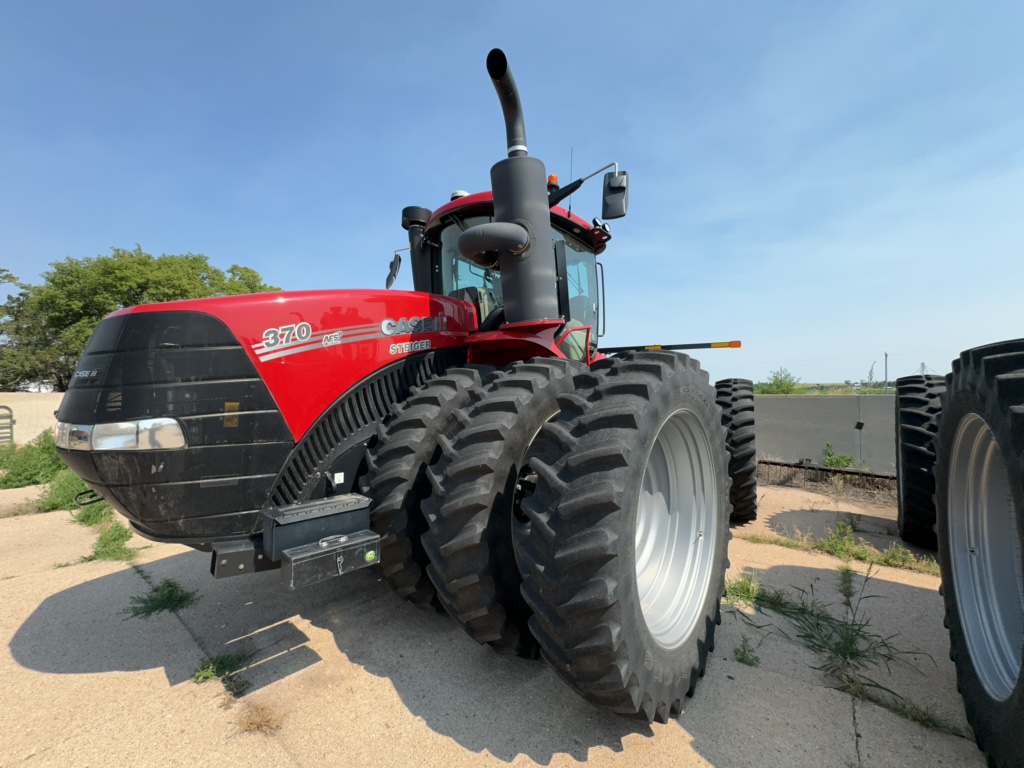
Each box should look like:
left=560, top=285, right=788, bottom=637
left=459, top=48, right=559, bottom=323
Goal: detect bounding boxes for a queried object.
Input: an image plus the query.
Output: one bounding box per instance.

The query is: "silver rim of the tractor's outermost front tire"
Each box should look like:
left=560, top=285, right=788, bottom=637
left=635, top=410, right=721, bottom=650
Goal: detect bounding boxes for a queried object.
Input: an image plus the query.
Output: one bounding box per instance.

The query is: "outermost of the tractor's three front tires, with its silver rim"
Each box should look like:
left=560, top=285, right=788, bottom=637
left=516, top=352, right=731, bottom=723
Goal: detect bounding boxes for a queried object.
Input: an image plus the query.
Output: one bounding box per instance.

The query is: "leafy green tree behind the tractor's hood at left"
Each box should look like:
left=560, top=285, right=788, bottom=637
left=0, top=246, right=281, bottom=392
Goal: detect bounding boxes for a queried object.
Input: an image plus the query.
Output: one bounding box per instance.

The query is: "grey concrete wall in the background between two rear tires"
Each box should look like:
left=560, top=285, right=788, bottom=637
left=754, top=394, right=896, bottom=472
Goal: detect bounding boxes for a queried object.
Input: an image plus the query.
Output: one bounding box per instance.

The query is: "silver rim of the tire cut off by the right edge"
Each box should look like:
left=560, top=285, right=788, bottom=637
left=947, top=414, right=1024, bottom=701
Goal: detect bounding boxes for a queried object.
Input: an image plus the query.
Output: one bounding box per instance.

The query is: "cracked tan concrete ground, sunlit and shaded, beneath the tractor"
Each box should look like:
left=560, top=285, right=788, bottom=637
left=0, top=487, right=984, bottom=768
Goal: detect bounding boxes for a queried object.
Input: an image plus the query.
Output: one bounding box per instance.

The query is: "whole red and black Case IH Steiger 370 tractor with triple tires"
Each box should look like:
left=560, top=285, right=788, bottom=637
left=57, top=50, right=756, bottom=722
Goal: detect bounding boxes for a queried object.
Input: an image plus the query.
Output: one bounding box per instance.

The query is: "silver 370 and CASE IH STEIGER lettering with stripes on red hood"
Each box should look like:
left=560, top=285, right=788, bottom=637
left=253, top=314, right=447, bottom=362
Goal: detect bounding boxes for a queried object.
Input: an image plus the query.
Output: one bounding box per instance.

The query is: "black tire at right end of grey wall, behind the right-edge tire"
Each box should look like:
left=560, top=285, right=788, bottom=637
left=896, top=376, right=946, bottom=550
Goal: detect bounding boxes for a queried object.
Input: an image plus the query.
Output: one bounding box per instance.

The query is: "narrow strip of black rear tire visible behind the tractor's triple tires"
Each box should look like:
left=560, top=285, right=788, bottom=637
left=715, top=379, right=758, bottom=525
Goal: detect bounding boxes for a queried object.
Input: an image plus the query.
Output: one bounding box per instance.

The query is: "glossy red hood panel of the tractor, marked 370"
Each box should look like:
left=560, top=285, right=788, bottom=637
left=114, top=291, right=476, bottom=440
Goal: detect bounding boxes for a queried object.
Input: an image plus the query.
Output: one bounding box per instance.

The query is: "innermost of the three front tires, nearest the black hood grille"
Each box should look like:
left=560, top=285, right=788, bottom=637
left=360, top=367, right=492, bottom=607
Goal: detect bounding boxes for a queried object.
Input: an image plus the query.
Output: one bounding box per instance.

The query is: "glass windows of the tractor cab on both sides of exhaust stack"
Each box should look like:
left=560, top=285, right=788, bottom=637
left=439, top=216, right=599, bottom=331
